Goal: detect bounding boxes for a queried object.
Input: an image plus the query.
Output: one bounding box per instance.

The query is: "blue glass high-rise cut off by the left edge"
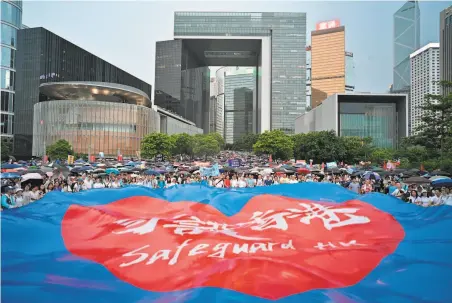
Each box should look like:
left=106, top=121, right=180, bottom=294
left=0, top=0, right=22, bottom=145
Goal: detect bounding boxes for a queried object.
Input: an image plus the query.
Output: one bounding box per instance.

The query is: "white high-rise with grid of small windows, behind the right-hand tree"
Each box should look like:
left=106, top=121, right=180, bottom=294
left=410, top=43, right=441, bottom=135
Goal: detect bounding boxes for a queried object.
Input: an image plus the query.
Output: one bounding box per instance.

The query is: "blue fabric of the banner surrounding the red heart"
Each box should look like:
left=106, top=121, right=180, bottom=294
left=1, top=183, right=452, bottom=303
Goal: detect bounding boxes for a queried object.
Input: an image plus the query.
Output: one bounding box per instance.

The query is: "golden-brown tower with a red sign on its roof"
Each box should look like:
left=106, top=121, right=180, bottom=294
left=311, top=20, right=345, bottom=108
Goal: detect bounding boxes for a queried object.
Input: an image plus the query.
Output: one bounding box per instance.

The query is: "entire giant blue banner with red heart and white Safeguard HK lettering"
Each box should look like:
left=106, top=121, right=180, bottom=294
left=1, top=183, right=452, bottom=303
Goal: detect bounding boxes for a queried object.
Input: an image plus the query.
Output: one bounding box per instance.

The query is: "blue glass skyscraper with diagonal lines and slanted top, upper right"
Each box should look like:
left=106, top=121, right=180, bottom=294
left=392, top=1, right=421, bottom=92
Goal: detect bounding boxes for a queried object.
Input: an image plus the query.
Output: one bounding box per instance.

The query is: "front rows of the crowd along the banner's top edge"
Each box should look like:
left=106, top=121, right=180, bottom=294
left=1, top=164, right=452, bottom=209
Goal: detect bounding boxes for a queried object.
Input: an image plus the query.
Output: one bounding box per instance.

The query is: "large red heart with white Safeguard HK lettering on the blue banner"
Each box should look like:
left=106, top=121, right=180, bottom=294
left=62, top=195, right=405, bottom=300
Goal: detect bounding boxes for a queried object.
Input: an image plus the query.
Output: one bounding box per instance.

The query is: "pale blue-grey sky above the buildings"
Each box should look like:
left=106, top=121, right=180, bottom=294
left=22, top=0, right=452, bottom=92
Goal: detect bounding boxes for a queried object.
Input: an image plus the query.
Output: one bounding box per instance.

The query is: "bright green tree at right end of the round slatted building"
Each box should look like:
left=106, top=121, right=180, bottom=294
left=141, top=133, right=174, bottom=159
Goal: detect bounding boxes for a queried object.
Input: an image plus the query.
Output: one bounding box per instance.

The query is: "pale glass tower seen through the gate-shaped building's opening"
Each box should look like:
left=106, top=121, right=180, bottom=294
left=224, top=73, right=257, bottom=144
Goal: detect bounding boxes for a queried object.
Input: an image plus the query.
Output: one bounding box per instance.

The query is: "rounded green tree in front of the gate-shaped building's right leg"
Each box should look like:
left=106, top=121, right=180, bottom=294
left=253, top=130, right=294, bottom=160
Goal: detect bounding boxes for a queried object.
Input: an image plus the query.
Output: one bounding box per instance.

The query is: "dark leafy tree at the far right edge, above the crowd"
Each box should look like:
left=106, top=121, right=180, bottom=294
left=413, top=81, right=452, bottom=163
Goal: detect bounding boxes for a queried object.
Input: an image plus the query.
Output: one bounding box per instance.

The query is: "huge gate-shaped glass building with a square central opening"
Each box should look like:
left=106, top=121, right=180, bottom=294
left=155, top=12, right=306, bottom=133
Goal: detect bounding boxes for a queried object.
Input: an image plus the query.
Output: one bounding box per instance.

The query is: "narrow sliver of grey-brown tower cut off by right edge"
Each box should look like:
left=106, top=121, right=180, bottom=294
left=439, top=6, right=452, bottom=94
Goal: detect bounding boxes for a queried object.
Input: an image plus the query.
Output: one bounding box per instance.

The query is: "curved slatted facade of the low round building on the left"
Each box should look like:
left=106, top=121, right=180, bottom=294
left=33, top=100, right=160, bottom=157
